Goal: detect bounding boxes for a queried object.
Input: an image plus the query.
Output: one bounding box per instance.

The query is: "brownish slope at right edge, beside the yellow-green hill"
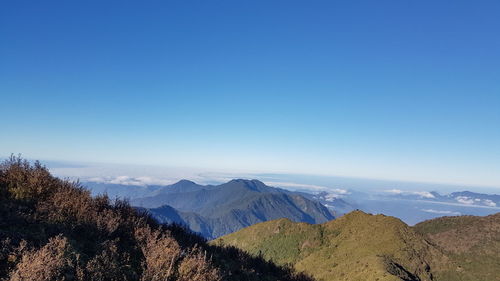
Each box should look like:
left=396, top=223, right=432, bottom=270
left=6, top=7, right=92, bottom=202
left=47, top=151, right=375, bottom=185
left=414, top=213, right=500, bottom=281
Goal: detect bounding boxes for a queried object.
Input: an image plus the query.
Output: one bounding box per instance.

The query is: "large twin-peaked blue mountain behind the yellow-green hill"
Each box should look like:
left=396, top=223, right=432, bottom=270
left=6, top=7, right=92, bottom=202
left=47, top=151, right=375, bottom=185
left=131, top=179, right=334, bottom=238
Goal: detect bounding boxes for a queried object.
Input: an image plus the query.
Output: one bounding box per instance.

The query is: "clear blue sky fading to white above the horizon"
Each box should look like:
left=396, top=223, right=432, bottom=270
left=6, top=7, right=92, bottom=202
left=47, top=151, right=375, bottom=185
left=0, top=0, right=500, bottom=187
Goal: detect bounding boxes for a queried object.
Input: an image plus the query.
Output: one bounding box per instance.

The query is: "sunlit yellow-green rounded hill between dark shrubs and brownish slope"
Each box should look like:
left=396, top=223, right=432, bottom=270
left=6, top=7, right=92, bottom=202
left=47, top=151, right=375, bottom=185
left=213, top=211, right=445, bottom=281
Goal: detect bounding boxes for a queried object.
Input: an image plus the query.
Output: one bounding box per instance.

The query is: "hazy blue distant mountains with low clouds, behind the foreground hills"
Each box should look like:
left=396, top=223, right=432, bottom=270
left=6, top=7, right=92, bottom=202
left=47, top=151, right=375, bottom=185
left=85, top=178, right=500, bottom=234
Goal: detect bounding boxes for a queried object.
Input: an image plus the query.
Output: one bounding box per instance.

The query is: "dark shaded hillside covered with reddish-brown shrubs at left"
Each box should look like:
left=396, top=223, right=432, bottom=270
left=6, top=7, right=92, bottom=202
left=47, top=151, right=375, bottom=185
left=0, top=157, right=312, bottom=281
